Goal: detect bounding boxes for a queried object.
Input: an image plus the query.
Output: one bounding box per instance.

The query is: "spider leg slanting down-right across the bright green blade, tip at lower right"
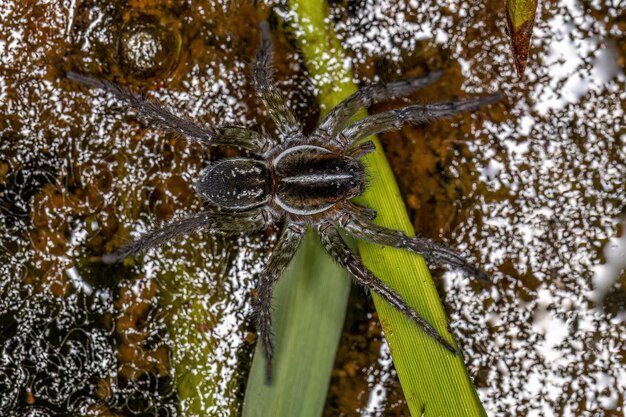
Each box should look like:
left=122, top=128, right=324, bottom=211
left=318, top=222, right=458, bottom=355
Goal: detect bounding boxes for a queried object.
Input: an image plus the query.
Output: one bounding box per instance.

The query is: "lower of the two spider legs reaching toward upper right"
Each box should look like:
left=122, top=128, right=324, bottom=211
left=342, top=93, right=502, bottom=144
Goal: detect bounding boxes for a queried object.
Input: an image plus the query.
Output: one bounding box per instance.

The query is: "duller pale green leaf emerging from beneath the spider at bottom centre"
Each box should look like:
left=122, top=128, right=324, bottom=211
left=243, top=232, right=350, bottom=417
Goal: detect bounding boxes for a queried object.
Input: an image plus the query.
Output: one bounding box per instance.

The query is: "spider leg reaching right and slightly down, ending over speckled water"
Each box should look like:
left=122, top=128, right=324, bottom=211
left=341, top=208, right=490, bottom=282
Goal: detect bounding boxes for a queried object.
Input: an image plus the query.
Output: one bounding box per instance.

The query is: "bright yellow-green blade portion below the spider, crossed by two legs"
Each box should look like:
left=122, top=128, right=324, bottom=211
left=358, top=154, right=486, bottom=417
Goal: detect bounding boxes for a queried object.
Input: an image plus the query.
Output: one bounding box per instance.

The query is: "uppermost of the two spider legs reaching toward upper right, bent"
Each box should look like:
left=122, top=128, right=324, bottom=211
left=313, top=71, right=442, bottom=146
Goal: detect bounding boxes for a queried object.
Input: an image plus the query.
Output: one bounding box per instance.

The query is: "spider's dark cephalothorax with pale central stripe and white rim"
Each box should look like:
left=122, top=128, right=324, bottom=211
left=273, top=145, right=365, bottom=215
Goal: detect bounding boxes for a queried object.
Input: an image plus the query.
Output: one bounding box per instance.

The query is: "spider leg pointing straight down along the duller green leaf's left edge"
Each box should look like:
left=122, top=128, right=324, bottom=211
left=254, top=224, right=304, bottom=384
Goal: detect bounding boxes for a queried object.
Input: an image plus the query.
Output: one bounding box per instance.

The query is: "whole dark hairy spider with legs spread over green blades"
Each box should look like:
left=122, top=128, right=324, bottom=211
left=67, top=23, right=500, bottom=383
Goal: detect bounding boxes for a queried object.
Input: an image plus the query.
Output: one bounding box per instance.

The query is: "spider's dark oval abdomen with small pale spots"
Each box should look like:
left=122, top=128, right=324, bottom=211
left=196, top=158, right=272, bottom=210
